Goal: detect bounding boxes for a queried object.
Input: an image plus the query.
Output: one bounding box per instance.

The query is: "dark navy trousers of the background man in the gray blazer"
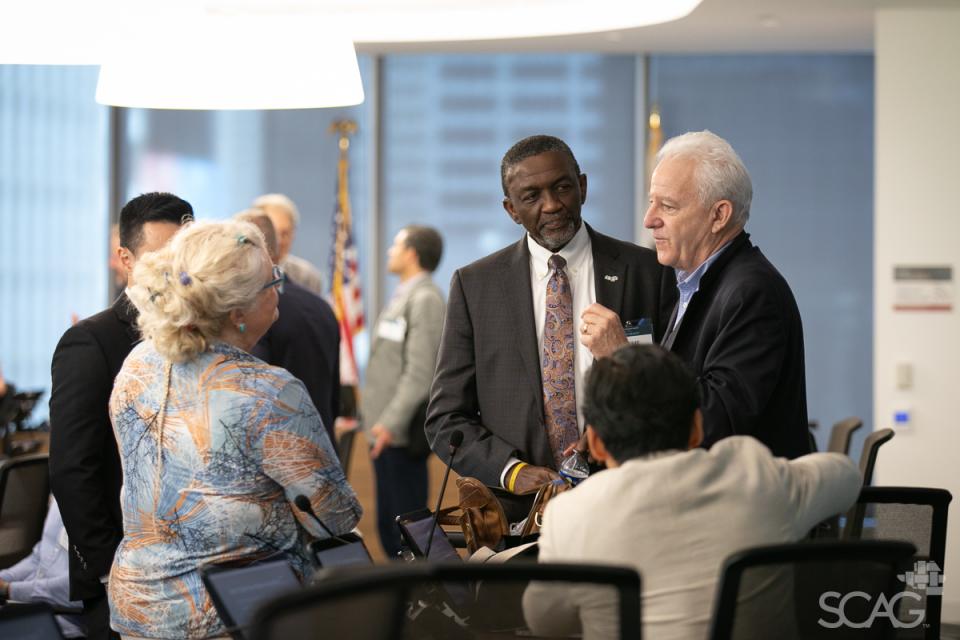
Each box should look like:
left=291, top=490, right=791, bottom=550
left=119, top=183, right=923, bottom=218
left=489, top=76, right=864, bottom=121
left=373, top=447, right=427, bottom=559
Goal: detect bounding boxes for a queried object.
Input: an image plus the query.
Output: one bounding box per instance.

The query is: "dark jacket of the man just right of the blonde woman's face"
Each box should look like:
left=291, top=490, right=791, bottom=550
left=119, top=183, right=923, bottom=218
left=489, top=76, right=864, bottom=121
left=253, top=280, right=340, bottom=443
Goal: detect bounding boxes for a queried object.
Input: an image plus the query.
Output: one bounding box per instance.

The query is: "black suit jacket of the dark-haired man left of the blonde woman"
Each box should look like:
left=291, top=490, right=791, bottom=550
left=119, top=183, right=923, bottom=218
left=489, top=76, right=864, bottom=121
left=50, top=295, right=139, bottom=600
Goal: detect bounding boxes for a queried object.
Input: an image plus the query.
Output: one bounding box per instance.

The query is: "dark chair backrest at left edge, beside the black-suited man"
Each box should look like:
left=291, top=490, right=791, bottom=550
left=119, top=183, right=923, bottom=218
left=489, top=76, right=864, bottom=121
left=0, top=453, right=50, bottom=567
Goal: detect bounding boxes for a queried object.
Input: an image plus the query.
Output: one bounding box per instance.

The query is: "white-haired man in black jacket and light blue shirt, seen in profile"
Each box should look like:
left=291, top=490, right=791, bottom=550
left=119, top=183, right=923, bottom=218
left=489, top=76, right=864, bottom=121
left=592, top=131, right=810, bottom=458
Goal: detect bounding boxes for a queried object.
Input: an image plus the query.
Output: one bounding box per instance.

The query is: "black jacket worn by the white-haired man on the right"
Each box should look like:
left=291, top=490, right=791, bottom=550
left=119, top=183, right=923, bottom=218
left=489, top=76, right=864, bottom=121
left=664, top=232, right=810, bottom=458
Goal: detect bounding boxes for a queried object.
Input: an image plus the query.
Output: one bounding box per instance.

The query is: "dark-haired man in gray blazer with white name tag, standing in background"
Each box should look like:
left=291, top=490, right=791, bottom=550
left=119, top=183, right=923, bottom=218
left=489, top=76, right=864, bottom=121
left=360, top=225, right=445, bottom=558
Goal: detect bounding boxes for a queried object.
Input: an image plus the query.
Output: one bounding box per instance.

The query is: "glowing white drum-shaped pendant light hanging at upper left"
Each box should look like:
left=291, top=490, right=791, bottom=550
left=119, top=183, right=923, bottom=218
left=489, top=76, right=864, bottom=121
left=97, top=11, right=363, bottom=109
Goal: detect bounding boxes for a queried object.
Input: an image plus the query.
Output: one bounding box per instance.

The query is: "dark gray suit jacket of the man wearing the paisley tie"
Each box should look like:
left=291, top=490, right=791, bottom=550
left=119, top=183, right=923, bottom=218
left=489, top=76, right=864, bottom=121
left=426, top=226, right=675, bottom=486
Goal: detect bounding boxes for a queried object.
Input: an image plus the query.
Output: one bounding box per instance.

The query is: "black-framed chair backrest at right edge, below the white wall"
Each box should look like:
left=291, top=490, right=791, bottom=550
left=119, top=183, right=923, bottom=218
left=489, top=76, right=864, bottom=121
left=843, top=487, right=953, bottom=639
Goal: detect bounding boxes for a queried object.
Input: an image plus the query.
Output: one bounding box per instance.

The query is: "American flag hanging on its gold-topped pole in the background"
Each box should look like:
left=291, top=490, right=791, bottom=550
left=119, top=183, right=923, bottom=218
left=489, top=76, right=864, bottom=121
left=330, top=145, right=364, bottom=386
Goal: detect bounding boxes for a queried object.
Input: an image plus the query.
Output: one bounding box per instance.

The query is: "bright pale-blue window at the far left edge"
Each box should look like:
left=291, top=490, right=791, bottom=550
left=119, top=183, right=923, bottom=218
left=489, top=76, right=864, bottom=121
left=0, top=65, right=109, bottom=410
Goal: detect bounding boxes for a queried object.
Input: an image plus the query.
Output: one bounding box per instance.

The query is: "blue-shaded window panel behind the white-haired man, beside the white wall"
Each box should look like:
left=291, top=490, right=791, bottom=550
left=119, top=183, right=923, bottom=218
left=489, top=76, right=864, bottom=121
left=650, top=55, right=874, bottom=455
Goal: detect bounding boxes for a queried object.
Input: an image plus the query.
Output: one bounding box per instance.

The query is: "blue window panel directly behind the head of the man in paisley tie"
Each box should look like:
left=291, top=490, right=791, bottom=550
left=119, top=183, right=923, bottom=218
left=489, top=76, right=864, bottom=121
left=379, top=54, right=635, bottom=304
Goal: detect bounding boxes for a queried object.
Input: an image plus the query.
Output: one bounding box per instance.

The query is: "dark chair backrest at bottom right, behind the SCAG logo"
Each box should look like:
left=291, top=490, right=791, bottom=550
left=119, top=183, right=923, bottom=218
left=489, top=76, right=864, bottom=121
left=708, top=541, right=921, bottom=640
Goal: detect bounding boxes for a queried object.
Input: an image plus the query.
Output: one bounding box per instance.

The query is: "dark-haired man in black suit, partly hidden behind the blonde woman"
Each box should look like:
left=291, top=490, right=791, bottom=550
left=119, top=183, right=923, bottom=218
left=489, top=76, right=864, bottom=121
left=50, top=193, right=193, bottom=638
